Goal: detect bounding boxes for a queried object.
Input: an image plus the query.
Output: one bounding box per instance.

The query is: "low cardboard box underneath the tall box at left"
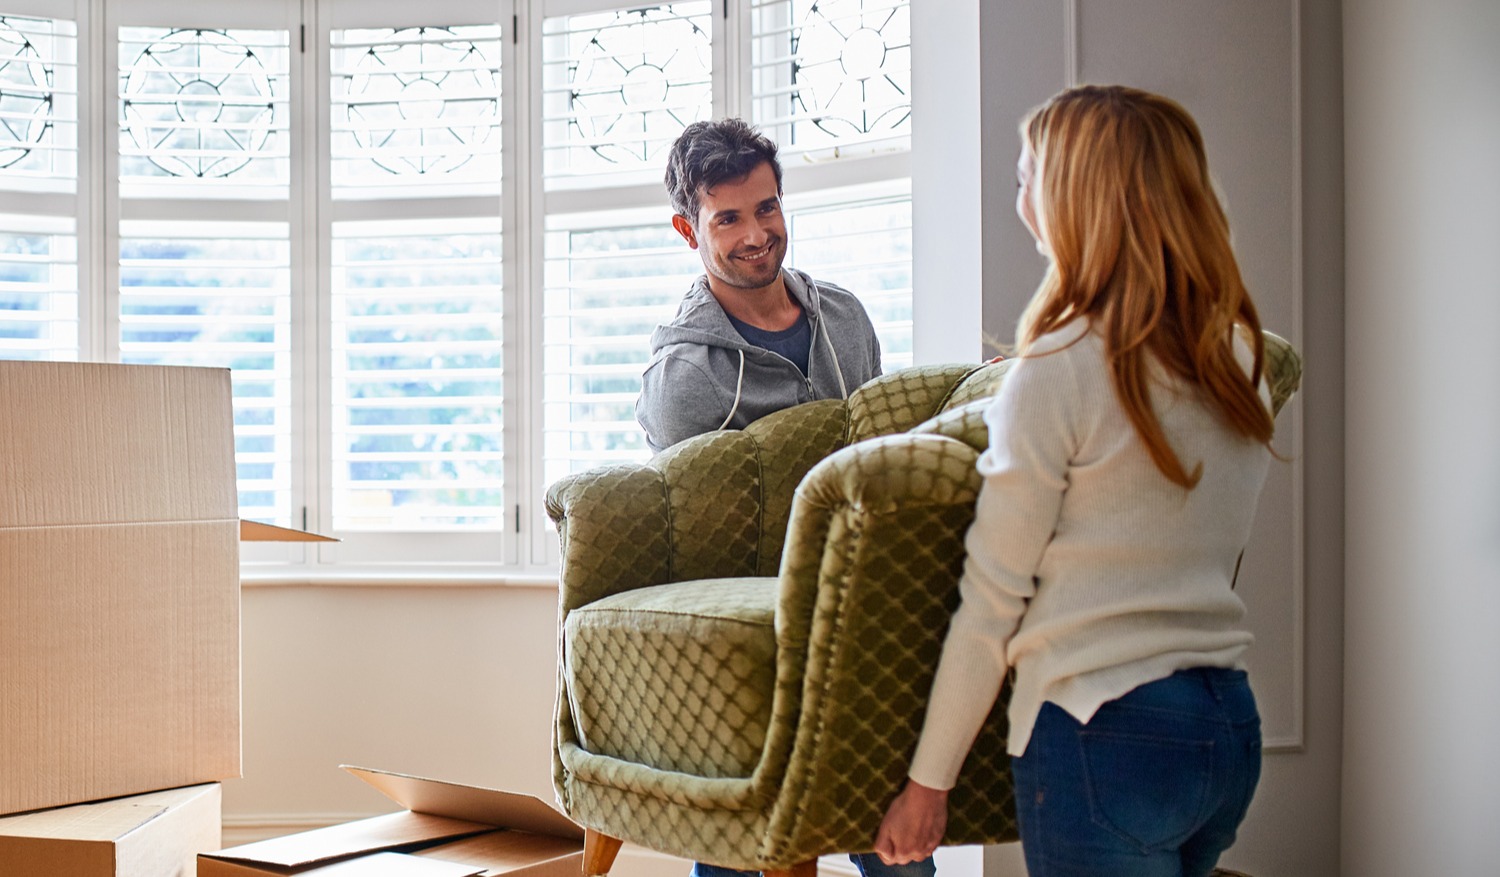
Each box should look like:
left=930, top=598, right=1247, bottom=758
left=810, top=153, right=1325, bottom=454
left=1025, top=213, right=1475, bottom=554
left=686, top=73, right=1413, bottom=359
left=0, top=783, right=221, bottom=877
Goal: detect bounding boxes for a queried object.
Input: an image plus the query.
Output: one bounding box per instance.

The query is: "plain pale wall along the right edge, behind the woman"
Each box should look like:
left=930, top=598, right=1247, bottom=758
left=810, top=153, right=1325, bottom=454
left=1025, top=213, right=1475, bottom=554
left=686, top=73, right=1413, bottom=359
left=1343, top=0, right=1500, bottom=877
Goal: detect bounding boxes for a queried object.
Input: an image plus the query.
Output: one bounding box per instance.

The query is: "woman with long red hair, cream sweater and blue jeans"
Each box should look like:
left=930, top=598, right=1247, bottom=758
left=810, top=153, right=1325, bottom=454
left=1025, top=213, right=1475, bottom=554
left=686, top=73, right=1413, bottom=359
left=876, top=87, right=1272, bottom=877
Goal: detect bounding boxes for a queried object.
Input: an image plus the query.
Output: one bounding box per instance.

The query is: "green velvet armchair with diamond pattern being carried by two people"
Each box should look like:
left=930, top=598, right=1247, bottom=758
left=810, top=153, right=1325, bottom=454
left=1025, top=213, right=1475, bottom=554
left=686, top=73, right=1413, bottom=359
left=548, top=334, right=1301, bottom=877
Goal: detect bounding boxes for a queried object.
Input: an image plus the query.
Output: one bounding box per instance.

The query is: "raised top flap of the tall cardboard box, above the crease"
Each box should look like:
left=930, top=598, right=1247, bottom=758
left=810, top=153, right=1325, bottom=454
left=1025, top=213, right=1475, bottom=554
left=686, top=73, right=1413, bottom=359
left=0, top=361, right=239, bottom=528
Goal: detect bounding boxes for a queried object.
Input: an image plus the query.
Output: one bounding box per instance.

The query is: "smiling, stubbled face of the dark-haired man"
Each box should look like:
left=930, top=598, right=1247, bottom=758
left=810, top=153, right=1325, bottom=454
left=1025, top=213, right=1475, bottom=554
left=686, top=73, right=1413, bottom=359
left=672, top=162, right=786, bottom=289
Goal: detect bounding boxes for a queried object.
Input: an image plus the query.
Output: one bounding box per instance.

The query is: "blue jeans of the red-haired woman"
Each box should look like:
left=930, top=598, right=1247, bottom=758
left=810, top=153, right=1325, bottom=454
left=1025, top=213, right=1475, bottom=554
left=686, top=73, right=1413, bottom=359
left=1011, top=667, right=1260, bottom=877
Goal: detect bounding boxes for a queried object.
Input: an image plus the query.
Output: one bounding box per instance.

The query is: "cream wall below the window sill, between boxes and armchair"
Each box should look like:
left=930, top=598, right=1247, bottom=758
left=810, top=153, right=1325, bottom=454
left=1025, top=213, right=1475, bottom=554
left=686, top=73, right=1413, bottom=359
left=224, top=585, right=557, bottom=828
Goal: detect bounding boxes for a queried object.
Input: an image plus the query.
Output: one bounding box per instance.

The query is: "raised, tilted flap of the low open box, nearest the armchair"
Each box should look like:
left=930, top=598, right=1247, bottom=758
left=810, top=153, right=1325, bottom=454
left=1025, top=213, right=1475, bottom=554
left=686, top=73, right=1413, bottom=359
left=341, top=765, right=584, bottom=841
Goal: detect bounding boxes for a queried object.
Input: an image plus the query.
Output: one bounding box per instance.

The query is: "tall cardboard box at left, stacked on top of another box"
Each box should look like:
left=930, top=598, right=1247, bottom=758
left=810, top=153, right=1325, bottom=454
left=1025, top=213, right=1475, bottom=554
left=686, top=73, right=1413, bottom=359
left=0, top=361, right=331, bottom=814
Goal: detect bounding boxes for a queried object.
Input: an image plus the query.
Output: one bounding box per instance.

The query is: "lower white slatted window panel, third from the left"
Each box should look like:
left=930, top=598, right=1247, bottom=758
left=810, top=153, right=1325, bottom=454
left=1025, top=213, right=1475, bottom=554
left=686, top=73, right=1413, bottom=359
left=332, top=219, right=506, bottom=531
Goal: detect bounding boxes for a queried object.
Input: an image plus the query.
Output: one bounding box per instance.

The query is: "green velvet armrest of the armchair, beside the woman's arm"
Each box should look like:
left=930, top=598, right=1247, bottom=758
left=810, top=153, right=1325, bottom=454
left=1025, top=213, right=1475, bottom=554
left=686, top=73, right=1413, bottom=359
left=758, top=433, right=1010, bottom=850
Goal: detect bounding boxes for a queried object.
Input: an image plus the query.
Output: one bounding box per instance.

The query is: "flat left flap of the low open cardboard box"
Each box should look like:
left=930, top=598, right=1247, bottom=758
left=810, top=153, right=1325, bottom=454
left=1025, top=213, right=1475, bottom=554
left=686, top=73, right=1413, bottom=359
left=204, top=811, right=492, bottom=868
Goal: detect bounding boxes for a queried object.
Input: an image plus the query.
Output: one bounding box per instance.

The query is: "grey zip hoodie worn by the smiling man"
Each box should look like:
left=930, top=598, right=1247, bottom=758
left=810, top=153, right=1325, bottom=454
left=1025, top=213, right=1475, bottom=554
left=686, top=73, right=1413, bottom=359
left=636, top=268, right=881, bottom=451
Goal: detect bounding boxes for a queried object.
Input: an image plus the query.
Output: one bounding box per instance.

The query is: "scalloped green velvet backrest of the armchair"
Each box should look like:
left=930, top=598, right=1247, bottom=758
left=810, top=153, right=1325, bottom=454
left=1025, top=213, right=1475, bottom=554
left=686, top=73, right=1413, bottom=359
left=548, top=333, right=1302, bottom=600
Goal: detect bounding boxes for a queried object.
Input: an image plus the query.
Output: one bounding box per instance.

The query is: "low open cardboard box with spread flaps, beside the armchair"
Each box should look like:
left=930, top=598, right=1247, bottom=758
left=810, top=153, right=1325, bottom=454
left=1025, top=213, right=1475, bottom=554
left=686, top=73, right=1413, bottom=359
left=198, top=766, right=584, bottom=877
